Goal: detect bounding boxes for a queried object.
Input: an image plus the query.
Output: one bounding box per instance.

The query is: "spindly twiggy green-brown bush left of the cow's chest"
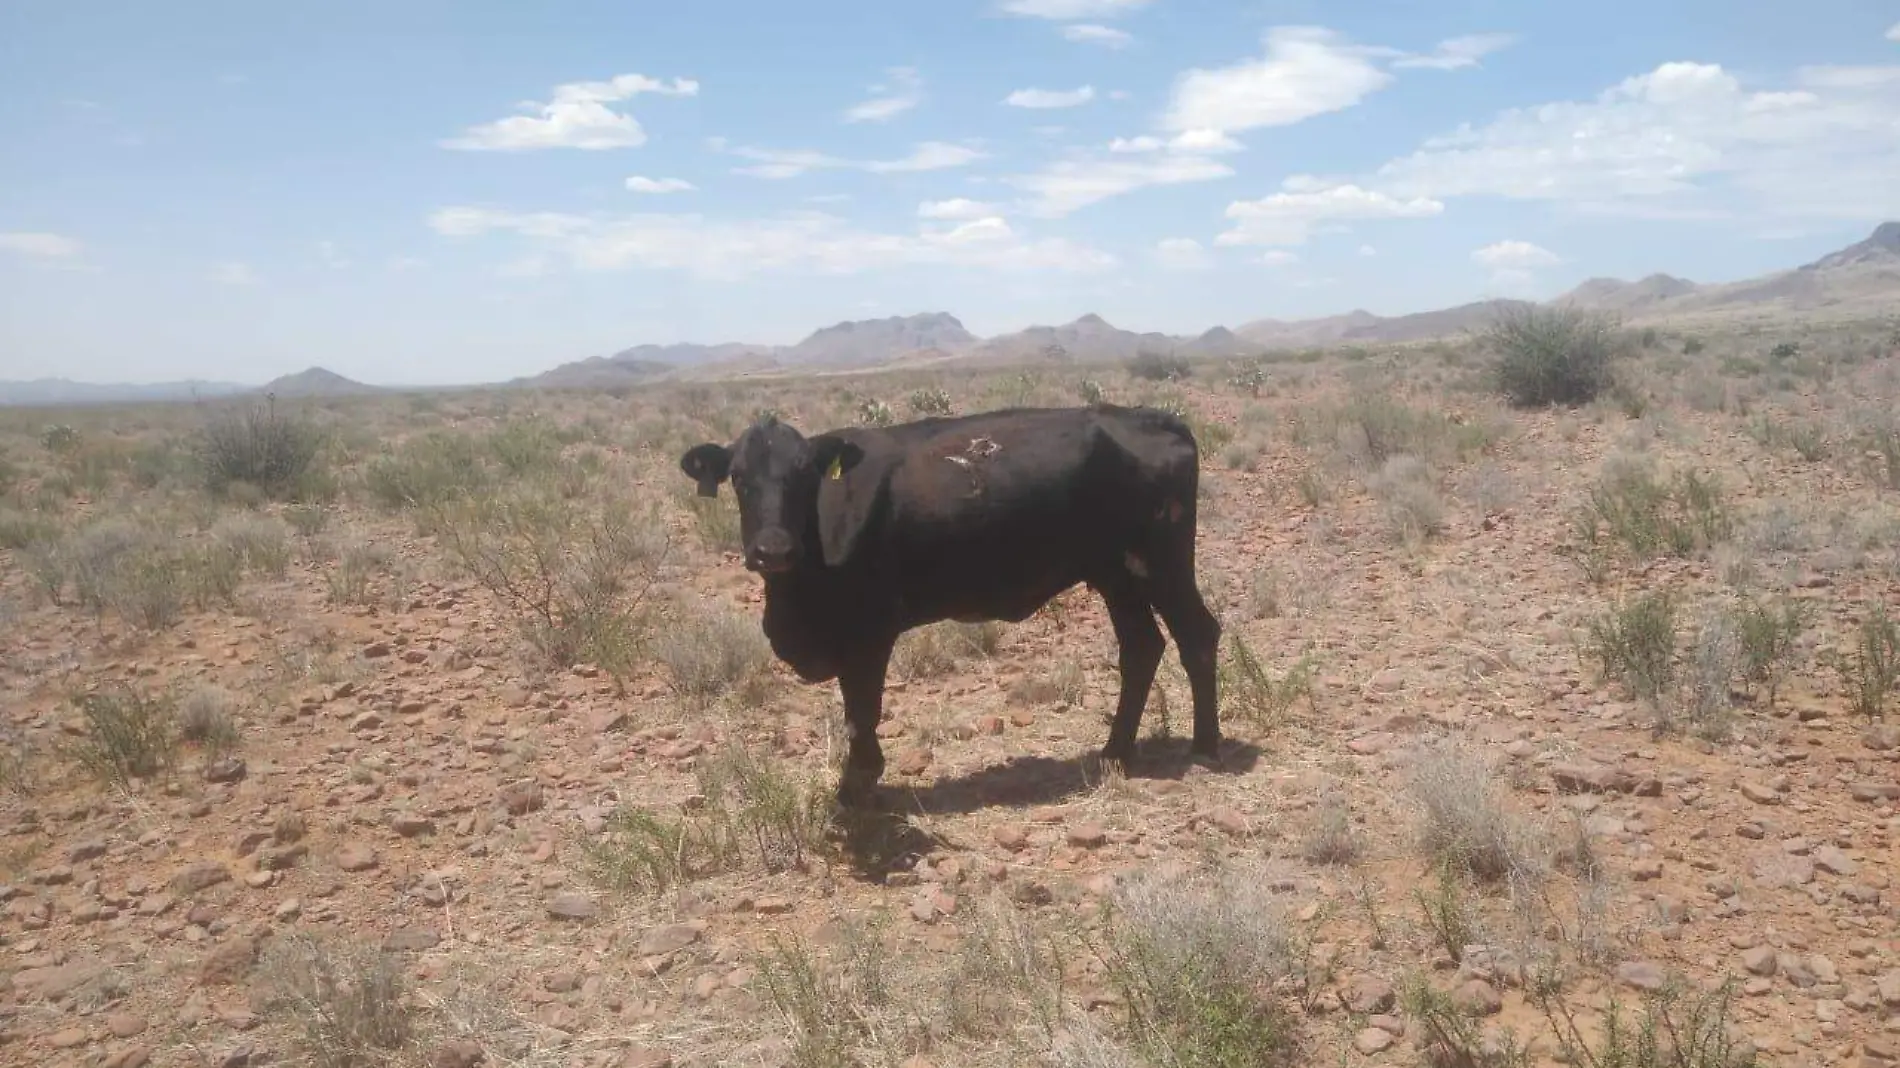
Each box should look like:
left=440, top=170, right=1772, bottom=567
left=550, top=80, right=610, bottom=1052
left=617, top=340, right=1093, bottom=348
left=431, top=485, right=669, bottom=680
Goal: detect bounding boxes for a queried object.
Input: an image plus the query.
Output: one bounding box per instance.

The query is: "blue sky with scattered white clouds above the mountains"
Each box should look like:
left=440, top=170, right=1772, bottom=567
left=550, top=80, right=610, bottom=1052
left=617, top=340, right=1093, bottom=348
left=0, top=0, right=1900, bottom=384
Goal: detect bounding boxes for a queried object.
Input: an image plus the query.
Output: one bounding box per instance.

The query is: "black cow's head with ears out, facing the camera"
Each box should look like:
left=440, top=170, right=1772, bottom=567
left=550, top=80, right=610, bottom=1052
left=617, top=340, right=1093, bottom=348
left=680, top=416, right=865, bottom=574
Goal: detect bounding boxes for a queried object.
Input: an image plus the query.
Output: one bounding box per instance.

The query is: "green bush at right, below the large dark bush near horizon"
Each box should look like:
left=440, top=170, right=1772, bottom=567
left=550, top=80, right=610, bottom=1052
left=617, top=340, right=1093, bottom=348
left=1573, top=462, right=1735, bottom=561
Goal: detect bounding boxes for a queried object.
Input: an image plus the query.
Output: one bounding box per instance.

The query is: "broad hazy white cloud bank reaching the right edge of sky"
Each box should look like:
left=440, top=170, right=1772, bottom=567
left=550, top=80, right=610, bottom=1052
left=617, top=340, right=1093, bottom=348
left=1364, top=63, right=1900, bottom=220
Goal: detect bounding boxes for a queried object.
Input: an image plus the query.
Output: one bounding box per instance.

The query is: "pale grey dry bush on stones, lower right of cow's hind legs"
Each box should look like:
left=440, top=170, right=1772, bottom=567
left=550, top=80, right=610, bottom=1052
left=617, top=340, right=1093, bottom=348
left=1406, top=737, right=1549, bottom=886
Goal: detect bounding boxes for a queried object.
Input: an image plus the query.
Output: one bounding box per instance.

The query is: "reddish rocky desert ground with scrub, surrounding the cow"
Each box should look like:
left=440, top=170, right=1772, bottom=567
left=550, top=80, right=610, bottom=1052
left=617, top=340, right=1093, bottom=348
left=0, top=307, right=1900, bottom=1068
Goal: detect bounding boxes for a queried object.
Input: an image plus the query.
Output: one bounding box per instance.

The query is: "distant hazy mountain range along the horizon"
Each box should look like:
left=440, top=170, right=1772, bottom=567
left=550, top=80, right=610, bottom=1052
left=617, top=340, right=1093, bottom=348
left=0, top=222, right=1900, bottom=405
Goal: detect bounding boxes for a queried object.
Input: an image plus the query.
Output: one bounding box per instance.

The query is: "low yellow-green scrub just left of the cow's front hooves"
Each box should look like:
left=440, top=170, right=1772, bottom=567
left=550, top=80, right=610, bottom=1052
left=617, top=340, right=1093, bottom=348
left=578, top=743, right=832, bottom=893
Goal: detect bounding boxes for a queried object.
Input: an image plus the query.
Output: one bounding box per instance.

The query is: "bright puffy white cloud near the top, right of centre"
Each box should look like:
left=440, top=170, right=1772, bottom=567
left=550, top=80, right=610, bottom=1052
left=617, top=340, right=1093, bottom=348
left=1163, top=27, right=1393, bottom=133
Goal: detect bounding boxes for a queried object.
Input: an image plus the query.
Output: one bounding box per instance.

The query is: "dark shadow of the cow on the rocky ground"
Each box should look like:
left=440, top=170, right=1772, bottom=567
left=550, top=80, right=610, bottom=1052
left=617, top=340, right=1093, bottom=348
left=830, top=739, right=1262, bottom=882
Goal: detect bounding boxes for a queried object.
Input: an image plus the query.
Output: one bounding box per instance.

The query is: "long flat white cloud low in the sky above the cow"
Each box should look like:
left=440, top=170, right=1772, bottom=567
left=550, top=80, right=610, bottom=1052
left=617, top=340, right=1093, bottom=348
left=429, top=207, right=1115, bottom=281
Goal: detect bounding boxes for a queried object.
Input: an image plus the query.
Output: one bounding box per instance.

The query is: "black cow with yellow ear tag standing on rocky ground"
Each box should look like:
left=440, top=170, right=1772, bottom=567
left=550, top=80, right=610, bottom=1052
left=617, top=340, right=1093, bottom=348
left=680, top=405, right=1220, bottom=806
